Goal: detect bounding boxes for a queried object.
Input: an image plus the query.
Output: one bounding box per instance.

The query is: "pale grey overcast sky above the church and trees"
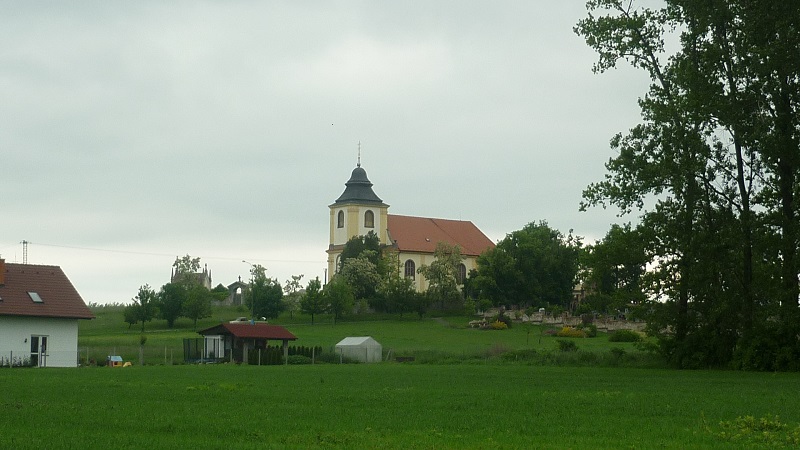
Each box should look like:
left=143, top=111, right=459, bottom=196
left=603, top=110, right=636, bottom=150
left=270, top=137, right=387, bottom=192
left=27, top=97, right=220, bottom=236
left=0, top=0, right=647, bottom=303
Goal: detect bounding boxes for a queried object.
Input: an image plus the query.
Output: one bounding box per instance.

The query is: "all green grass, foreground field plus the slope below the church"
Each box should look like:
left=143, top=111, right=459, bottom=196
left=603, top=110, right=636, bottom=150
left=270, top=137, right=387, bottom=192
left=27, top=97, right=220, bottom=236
left=6, top=308, right=788, bottom=449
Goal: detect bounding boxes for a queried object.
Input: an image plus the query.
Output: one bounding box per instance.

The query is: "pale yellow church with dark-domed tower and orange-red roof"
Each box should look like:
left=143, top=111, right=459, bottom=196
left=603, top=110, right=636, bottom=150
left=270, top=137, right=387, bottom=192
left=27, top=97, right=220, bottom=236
left=327, top=162, right=494, bottom=292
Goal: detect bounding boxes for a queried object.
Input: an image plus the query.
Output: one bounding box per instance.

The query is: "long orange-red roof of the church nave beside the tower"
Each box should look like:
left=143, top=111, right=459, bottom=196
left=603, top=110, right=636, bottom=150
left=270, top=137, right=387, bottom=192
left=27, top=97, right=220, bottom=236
left=388, top=214, right=494, bottom=256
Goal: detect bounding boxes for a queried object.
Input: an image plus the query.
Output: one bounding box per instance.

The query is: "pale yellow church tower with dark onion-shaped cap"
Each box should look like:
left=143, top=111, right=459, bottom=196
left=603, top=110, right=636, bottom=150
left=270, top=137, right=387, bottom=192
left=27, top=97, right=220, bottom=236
left=327, top=162, right=389, bottom=277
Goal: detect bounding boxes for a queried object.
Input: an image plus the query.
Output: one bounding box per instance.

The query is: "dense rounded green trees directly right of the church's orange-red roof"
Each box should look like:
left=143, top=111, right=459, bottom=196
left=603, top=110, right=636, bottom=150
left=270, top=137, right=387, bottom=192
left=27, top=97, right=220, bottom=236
left=474, top=221, right=581, bottom=308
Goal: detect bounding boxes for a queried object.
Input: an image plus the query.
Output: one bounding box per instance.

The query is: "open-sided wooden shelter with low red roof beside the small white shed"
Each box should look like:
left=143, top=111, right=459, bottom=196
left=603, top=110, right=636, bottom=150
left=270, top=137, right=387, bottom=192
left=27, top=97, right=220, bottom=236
left=198, top=322, right=297, bottom=362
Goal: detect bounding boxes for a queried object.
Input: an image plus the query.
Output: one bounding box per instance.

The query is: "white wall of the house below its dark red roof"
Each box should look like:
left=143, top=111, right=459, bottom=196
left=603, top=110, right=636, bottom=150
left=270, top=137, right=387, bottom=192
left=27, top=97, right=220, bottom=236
left=0, top=316, right=78, bottom=367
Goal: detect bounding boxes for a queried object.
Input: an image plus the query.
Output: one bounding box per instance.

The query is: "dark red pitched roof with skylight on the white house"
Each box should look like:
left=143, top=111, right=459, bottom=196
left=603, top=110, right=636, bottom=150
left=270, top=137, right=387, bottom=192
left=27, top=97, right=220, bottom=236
left=0, top=263, right=94, bottom=319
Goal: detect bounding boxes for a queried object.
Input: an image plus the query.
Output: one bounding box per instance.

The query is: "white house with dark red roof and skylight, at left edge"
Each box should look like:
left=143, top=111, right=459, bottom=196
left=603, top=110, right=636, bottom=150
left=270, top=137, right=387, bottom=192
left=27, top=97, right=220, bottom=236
left=0, top=259, right=94, bottom=367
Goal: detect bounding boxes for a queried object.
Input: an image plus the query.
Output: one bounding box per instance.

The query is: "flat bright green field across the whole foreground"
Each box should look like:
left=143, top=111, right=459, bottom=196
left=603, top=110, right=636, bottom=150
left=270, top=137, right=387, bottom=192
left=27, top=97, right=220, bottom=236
left=0, top=363, right=800, bottom=449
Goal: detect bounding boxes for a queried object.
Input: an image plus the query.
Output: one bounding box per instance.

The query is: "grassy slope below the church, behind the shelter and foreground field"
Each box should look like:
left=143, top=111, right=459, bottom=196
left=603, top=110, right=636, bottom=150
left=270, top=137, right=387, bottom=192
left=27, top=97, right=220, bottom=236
left=79, top=307, right=637, bottom=364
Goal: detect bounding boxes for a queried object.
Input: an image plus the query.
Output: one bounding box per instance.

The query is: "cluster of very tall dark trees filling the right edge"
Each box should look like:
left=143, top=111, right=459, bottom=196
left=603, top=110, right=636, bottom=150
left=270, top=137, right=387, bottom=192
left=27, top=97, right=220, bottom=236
left=576, top=0, right=800, bottom=368
